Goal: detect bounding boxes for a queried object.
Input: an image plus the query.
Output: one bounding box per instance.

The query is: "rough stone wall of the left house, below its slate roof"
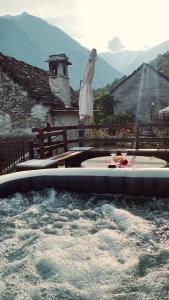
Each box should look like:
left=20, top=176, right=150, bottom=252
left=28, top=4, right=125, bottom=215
left=0, top=70, right=78, bottom=129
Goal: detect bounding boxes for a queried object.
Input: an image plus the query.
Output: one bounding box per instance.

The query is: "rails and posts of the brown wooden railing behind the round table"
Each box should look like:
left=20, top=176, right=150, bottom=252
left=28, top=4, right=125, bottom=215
left=31, top=122, right=169, bottom=158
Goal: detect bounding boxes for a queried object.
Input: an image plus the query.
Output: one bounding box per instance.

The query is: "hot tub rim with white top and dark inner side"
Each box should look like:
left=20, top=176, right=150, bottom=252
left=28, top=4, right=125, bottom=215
left=0, top=168, right=169, bottom=201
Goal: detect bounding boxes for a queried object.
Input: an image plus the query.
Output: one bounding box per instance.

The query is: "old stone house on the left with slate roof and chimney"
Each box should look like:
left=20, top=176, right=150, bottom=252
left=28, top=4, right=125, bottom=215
left=0, top=53, right=79, bottom=129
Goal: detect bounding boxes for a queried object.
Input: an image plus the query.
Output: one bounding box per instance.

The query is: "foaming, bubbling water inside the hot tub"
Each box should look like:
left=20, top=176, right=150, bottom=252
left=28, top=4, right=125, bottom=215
left=0, top=189, right=169, bottom=300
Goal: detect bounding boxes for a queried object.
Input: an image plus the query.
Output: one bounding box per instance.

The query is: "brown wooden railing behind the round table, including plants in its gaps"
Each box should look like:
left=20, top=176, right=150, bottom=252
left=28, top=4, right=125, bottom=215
left=29, top=123, right=169, bottom=158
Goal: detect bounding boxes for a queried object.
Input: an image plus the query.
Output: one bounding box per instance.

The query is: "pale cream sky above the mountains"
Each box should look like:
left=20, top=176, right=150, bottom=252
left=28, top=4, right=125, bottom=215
left=0, top=0, right=169, bottom=52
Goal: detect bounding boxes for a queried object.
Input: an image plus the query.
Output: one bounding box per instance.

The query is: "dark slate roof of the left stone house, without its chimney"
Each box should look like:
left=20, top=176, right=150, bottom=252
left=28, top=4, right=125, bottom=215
left=0, top=53, right=78, bottom=109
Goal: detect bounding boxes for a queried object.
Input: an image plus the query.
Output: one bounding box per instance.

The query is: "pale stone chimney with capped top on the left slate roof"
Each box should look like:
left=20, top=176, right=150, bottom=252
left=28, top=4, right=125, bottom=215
left=48, top=54, right=72, bottom=107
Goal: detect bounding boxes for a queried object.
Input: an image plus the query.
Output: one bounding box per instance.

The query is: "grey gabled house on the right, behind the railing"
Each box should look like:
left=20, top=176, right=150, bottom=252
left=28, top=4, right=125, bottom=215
left=111, top=63, right=169, bottom=122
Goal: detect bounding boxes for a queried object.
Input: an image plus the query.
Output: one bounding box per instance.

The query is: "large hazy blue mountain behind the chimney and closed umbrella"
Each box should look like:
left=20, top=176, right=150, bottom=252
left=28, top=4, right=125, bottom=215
left=0, top=13, right=122, bottom=89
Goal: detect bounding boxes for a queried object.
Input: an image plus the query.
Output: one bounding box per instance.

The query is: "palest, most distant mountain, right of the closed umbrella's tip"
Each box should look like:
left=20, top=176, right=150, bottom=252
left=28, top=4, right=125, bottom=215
left=99, top=41, right=169, bottom=75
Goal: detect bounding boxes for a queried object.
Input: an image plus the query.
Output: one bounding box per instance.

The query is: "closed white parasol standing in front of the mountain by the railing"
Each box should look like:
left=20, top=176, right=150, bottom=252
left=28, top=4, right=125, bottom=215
left=79, top=49, right=97, bottom=120
